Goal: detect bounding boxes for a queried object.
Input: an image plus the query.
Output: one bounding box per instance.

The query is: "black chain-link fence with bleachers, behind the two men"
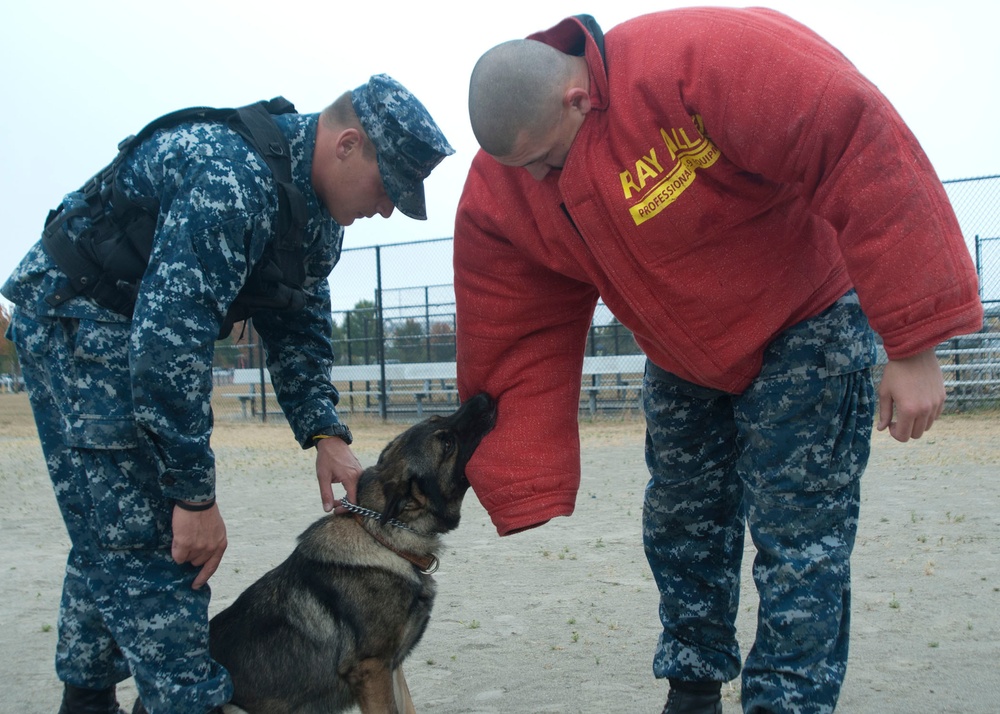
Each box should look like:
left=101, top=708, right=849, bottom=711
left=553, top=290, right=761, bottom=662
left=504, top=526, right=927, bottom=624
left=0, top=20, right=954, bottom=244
left=216, top=176, right=1000, bottom=420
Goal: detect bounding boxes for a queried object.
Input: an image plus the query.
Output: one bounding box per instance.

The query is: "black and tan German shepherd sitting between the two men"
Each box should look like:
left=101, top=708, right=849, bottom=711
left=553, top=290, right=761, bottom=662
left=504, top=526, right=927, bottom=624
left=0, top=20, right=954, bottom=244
left=210, top=394, right=496, bottom=714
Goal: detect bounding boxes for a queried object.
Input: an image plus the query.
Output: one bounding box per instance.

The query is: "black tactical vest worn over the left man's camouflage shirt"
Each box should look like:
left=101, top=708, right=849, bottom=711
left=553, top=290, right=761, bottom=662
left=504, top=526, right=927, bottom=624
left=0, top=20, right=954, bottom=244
left=42, top=97, right=307, bottom=338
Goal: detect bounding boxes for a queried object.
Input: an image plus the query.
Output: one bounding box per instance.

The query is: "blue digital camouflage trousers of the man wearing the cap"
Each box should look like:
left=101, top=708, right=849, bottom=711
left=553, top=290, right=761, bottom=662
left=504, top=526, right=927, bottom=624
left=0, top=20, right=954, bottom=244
left=8, top=310, right=232, bottom=714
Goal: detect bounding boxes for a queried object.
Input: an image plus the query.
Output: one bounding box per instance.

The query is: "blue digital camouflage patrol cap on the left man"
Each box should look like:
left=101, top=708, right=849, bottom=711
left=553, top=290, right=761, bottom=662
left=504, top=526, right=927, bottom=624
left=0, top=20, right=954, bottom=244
left=351, top=74, right=455, bottom=220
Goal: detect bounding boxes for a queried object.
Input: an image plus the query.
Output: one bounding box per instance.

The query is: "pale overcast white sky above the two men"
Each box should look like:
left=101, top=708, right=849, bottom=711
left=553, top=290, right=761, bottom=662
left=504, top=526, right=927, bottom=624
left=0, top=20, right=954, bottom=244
left=0, top=0, right=1000, bottom=304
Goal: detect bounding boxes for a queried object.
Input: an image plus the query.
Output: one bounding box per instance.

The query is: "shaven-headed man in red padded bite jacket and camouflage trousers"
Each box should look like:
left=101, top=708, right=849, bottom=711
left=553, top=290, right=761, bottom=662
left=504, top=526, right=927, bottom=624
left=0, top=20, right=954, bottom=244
left=455, top=9, right=983, bottom=714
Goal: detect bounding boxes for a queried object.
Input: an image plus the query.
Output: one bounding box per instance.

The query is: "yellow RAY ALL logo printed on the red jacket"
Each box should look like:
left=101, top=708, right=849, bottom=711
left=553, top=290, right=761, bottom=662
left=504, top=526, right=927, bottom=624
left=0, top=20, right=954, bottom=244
left=619, top=115, right=722, bottom=226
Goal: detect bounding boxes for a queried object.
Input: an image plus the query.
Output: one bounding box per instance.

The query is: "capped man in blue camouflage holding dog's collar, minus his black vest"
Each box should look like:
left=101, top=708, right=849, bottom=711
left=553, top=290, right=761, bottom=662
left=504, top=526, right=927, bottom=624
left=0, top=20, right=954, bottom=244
left=2, top=75, right=453, bottom=714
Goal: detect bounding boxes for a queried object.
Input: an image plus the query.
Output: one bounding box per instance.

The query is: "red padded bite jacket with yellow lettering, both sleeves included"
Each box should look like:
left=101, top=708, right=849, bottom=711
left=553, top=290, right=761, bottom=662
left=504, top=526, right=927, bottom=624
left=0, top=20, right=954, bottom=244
left=454, top=9, right=982, bottom=534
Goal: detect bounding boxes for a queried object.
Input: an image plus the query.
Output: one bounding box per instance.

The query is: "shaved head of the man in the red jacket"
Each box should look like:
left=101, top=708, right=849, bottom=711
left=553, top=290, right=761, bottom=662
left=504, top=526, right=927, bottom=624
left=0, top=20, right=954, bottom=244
left=469, top=40, right=586, bottom=156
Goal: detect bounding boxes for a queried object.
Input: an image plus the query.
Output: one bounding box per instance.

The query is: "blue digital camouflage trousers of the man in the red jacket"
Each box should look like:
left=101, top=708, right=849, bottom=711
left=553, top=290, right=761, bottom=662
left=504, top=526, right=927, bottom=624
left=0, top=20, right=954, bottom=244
left=643, top=291, right=875, bottom=714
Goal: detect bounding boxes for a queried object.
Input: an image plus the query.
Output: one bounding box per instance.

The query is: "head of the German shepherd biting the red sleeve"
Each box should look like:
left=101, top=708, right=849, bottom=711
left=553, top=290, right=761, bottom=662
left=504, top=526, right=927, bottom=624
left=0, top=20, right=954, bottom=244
left=358, top=394, right=496, bottom=533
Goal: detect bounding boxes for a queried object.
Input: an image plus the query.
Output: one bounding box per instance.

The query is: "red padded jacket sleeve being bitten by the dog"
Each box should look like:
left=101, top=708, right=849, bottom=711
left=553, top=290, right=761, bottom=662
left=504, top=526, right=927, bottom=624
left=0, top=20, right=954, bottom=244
left=454, top=154, right=597, bottom=535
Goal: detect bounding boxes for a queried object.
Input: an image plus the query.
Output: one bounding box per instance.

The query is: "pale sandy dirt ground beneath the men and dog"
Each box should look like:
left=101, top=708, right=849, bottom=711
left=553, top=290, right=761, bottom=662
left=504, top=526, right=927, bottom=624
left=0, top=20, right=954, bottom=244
left=0, top=394, right=1000, bottom=714
